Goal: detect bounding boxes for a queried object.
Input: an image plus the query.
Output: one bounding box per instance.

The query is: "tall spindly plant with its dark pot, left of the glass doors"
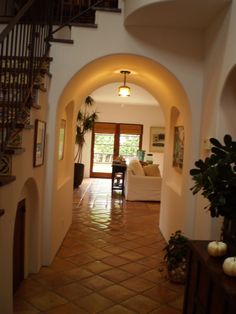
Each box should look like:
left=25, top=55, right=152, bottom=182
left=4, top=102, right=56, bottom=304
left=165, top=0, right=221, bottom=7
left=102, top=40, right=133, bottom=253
left=74, top=96, right=98, bottom=188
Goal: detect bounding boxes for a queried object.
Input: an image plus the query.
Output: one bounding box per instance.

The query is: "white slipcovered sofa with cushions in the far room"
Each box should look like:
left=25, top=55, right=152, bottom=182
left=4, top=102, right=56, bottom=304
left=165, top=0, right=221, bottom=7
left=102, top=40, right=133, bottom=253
left=125, top=159, right=162, bottom=201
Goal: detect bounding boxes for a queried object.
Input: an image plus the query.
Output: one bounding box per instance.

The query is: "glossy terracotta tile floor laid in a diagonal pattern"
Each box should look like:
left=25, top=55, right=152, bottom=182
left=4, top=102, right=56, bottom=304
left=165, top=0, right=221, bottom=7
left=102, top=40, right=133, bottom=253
left=14, top=179, right=184, bottom=314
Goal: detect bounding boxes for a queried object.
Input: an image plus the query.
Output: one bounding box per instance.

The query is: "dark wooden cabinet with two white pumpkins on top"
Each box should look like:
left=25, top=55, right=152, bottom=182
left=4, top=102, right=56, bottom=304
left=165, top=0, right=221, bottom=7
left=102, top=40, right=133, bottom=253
left=183, top=240, right=236, bottom=314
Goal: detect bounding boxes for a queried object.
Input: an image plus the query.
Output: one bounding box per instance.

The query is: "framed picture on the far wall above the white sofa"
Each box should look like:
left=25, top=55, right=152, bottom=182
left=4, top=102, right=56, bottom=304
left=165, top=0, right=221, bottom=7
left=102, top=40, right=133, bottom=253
left=149, top=126, right=165, bottom=152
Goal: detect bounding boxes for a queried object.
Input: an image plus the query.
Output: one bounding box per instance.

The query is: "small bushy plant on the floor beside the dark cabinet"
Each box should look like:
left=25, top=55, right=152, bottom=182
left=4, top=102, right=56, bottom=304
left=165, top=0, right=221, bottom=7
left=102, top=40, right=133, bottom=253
left=164, top=230, right=188, bottom=271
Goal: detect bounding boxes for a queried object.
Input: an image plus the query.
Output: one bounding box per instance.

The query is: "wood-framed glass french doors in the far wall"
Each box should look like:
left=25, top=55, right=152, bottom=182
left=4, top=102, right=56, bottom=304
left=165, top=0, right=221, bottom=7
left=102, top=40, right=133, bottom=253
left=90, top=122, right=143, bottom=178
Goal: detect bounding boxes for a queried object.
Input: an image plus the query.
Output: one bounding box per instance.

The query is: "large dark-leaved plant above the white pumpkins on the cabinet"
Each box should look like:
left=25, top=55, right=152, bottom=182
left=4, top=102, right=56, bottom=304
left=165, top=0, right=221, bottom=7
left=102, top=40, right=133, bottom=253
left=190, top=134, right=236, bottom=219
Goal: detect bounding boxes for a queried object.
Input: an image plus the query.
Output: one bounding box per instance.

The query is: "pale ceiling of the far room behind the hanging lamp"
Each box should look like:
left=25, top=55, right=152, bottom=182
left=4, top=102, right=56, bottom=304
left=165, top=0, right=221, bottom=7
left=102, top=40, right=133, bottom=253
left=91, top=82, right=158, bottom=106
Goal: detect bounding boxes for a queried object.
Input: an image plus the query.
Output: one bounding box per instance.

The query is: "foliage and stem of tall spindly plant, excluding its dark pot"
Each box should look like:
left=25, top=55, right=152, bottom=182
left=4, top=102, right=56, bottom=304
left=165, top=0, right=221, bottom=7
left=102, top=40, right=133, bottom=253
left=75, top=96, right=98, bottom=163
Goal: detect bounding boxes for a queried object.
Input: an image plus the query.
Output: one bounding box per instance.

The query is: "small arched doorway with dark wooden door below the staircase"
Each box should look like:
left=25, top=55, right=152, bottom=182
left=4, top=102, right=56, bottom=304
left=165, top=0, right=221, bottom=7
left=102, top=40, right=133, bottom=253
left=13, top=178, right=39, bottom=292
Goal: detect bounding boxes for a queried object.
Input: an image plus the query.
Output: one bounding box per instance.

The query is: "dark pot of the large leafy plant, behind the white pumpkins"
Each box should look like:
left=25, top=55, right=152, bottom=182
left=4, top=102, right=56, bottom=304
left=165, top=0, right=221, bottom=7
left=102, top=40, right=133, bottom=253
left=222, top=217, right=236, bottom=256
